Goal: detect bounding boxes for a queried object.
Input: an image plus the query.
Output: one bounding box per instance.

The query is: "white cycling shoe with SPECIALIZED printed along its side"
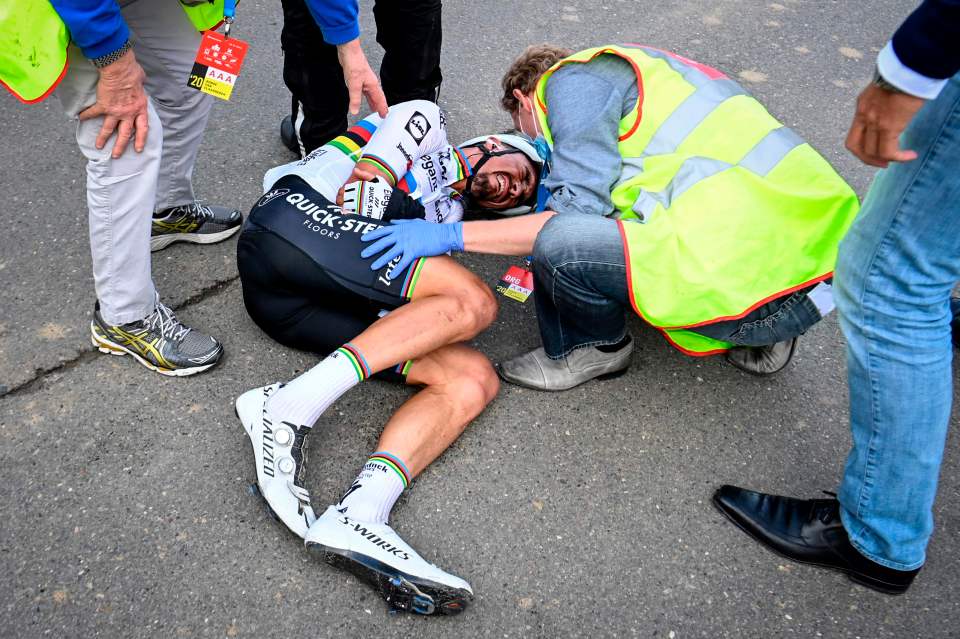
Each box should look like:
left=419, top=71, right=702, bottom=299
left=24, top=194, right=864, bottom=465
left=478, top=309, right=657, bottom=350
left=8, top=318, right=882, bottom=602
left=237, top=384, right=317, bottom=537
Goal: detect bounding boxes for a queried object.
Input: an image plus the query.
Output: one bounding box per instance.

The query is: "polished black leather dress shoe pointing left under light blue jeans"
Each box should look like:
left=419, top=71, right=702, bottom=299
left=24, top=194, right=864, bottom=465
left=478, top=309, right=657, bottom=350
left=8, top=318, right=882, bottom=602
left=713, top=486, right=920, bottom=595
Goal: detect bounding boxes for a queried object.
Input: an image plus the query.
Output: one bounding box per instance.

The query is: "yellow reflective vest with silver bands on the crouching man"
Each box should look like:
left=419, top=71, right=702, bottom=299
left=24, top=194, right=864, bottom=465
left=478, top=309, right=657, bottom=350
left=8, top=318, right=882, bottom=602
left=535, top=45, right=859, bottom=355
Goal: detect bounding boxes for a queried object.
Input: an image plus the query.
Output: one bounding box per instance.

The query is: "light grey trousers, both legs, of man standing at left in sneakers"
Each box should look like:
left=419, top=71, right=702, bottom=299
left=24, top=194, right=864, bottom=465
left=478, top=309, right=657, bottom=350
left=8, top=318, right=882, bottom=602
left=56, top=0, right=213, bottom=324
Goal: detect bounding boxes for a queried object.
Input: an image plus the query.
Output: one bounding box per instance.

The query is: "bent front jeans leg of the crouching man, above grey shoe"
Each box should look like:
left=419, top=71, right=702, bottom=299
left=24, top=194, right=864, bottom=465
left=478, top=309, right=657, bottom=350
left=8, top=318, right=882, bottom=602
left=533, top=213, right=630, bottom=359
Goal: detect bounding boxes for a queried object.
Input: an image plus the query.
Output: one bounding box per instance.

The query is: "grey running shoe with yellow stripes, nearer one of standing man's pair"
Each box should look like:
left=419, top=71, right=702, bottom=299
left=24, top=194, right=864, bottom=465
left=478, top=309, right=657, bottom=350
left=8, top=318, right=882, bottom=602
left=90, top=299, right=223, bottom=377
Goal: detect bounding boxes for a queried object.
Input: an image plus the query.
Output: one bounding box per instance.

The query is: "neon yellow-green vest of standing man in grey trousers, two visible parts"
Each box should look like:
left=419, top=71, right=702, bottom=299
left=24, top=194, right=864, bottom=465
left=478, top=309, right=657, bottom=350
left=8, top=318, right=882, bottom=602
left=0, top=0, right=223, bottom=103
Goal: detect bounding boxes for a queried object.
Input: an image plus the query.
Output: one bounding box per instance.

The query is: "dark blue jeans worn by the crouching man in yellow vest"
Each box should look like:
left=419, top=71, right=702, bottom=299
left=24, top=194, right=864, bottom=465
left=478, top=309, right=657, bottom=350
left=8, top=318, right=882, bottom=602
left=533, top=213, right=821, bottom=359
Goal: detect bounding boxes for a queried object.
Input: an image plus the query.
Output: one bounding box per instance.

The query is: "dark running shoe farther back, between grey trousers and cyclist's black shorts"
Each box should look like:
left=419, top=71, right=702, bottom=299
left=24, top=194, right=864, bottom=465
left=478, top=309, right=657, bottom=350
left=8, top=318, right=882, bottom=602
left=150, top=202, right=243, bottom=251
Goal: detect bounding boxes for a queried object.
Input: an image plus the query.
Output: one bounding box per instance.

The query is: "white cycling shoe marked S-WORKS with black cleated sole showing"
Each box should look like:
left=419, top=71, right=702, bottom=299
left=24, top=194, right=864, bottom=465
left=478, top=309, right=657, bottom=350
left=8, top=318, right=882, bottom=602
left=305, top=506, right=473, bottom=615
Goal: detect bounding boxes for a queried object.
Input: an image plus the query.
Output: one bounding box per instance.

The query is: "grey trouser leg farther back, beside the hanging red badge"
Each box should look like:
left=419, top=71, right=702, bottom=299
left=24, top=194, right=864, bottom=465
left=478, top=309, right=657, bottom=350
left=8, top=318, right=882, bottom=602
left=122, top=0, right=213, bottom=210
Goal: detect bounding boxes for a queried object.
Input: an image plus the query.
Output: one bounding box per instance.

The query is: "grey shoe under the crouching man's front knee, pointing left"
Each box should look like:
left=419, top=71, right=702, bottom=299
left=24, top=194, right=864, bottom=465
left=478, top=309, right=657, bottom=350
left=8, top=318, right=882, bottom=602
left=496, top=338, right=633, bottom=391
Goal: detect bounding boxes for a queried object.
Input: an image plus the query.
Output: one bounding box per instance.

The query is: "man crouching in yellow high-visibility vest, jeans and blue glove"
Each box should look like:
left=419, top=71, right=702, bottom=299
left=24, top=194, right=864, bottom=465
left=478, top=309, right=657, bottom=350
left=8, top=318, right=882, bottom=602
left=360, top=45, right=859, bottom=390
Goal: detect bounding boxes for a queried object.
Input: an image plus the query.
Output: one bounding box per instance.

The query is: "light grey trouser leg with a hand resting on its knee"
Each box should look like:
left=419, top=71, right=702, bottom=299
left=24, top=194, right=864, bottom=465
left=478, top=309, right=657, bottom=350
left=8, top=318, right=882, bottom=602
left=56, top=44, right=163, bottom=324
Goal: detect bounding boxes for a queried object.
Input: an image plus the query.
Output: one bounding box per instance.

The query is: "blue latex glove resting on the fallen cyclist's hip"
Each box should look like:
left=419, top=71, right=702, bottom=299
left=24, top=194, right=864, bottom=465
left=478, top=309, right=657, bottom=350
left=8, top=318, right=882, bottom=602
left=360, top=220, right=463, bottom=278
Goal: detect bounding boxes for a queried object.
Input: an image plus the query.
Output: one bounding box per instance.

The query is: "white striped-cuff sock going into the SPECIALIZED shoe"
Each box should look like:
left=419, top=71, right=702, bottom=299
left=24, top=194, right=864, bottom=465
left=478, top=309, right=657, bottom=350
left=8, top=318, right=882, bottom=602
left=267, top=343, right=370, bottom=427
